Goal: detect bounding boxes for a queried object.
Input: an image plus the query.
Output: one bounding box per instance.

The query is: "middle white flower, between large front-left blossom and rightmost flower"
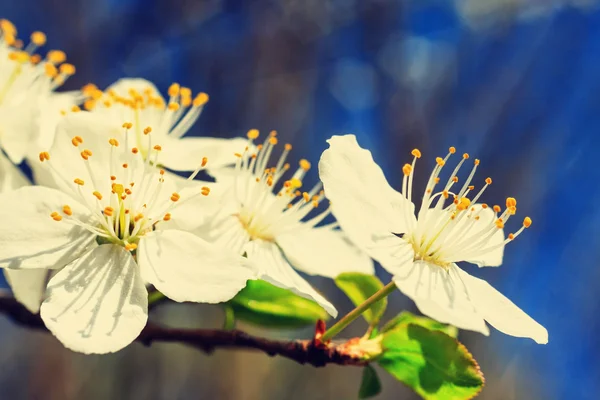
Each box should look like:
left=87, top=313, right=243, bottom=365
left=196, top=130, right=373, bottom=316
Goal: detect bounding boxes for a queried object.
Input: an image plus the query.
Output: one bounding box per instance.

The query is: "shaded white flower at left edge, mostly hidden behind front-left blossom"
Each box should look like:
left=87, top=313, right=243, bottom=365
left=0, top=151, right=48, bottom=313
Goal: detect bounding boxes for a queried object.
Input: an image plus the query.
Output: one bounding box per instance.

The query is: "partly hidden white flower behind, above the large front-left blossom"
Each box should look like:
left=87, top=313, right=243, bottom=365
left=78, top=78, right=246, bottom=171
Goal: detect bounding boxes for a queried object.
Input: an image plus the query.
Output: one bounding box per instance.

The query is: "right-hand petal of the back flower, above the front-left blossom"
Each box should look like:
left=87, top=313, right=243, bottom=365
left=160, top=137, right=248, bottom=171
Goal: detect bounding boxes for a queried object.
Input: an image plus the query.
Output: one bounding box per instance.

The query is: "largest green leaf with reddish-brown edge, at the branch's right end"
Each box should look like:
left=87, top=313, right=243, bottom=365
left=378, top=323, right=484, bottom=400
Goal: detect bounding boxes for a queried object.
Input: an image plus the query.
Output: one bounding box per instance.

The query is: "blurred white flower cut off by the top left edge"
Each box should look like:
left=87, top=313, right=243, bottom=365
left=0, top=19, right=80, bottom=164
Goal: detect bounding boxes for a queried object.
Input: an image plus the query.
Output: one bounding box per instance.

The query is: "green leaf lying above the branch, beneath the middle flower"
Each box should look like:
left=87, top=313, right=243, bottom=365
left=227, top=280, right=329, bottom=328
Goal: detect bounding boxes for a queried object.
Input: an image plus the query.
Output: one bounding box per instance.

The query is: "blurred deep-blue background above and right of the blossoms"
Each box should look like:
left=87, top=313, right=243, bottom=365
left=0, top=0, right=600, bottom=399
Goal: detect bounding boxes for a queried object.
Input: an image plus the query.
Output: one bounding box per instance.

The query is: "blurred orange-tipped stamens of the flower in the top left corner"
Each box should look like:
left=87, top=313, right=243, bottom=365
left=0, top=19, right=75, bottom=105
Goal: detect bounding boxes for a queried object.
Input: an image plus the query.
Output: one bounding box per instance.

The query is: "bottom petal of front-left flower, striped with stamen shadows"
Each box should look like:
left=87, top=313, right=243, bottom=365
left=40, top=244, right=148, bottom=354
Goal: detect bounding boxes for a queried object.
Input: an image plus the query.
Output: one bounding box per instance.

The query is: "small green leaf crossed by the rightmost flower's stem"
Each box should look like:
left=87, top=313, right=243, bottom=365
left=335, top=272, right=387, bottom=326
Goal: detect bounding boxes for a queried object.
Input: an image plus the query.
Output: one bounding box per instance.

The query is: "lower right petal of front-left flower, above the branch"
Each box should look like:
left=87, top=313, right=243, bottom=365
left=137, top=230, right=257, bottom=303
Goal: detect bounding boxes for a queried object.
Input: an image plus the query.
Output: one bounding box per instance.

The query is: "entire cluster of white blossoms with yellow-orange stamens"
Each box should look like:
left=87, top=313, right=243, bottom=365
left=0, top=20, right=548, bottom=353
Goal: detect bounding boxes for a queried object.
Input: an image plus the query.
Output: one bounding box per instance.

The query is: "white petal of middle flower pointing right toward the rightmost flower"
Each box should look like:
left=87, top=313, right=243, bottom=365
left=276, top=228, right=374, bottom=278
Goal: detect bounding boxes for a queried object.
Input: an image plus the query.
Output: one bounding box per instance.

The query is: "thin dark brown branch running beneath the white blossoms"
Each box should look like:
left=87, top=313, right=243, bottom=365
left=0, top=297, right=366, bottom=367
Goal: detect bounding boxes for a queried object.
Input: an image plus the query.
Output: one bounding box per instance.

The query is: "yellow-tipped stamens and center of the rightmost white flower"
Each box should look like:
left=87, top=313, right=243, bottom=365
left=402, top=147, right=531, bottom=268
